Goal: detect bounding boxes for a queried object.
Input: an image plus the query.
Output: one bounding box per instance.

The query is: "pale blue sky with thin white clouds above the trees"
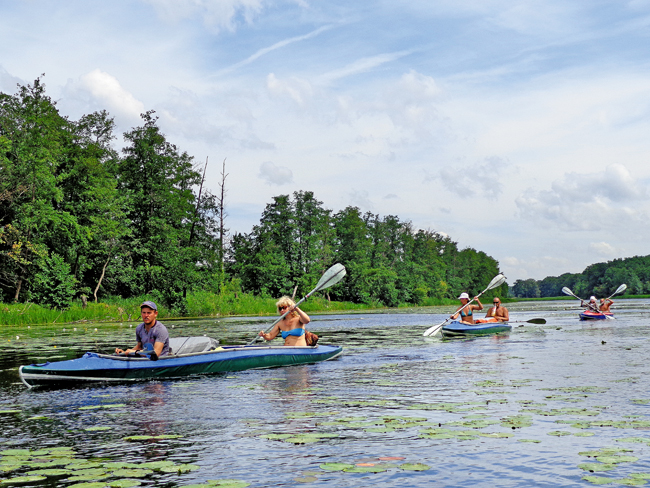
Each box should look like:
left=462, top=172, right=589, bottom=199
left=0, top=0, right=650, bottom=284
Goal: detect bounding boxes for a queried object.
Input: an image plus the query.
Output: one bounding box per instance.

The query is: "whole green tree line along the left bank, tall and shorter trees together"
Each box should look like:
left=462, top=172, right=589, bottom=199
left=0, top=79, right=507, bottom=314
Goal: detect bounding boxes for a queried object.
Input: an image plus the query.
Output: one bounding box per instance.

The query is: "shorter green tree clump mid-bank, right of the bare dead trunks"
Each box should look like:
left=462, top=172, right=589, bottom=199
left=226, top=191, right=507, bottom=307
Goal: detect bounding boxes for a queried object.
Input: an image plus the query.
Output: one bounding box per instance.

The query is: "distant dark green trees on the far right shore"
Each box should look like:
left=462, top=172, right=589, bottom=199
left=512, top=256, right=650, bottom=298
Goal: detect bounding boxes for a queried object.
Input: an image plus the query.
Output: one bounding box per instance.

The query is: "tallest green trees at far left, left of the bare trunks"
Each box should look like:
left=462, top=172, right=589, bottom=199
left=0, top=79, right=221, bottom=313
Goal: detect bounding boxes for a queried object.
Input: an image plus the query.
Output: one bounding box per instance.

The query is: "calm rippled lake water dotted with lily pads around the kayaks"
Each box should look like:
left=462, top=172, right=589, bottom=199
left=0, top=300, right=650, bottom=487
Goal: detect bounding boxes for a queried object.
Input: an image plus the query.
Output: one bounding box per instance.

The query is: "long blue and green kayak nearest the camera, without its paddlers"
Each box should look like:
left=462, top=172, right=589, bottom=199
left=19, top=337, right=342, bottom=388
